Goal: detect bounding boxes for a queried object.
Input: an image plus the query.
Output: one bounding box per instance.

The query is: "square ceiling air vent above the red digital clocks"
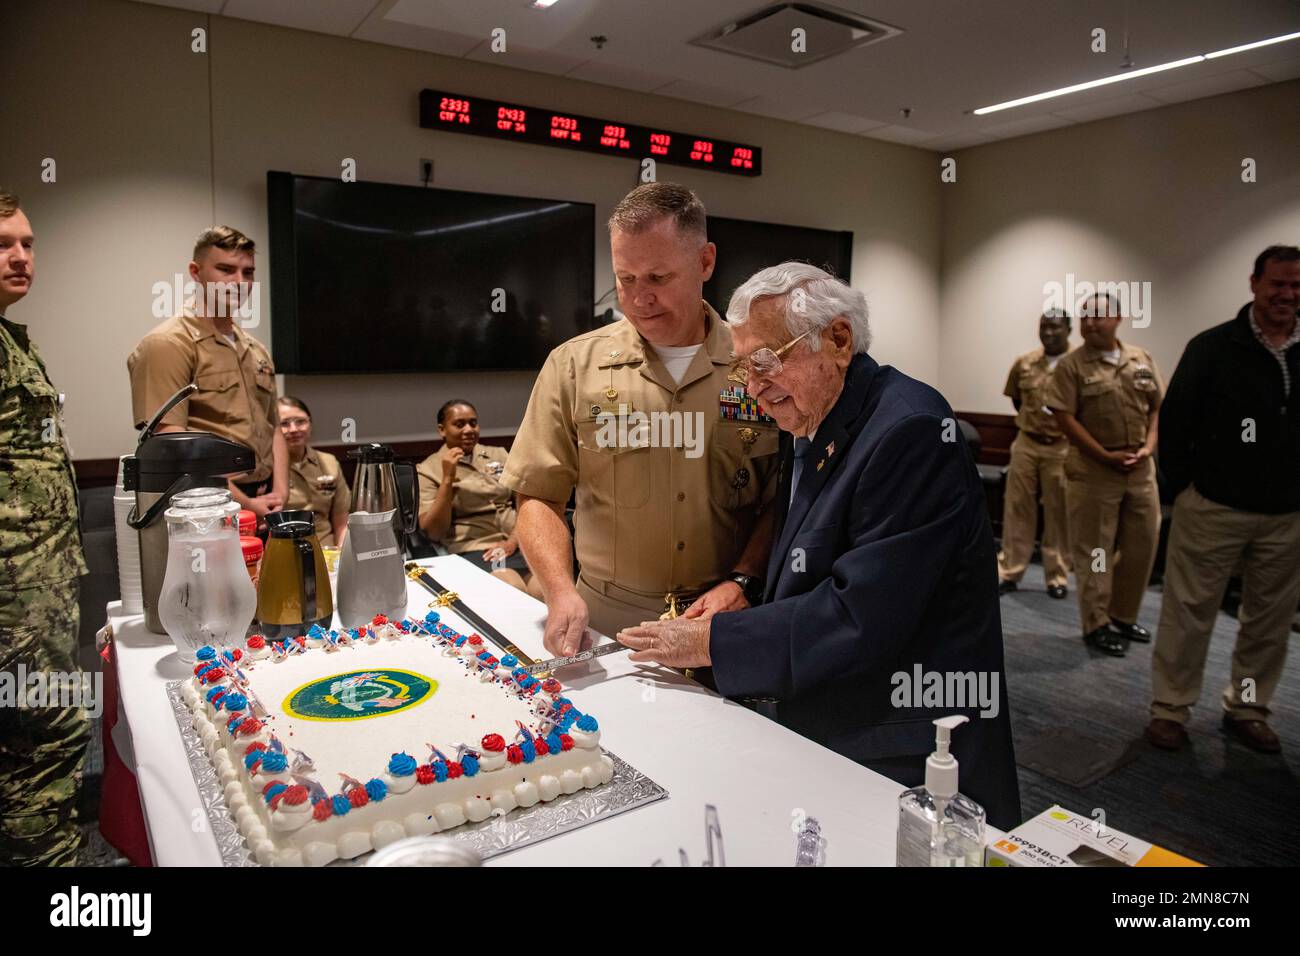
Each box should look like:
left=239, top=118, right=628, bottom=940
left=692, top=4, right=902, bottom=70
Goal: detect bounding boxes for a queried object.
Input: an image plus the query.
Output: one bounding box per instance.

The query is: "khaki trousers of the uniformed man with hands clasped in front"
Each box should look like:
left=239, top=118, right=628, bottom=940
left=1065, top=447, right=1160, bottom=633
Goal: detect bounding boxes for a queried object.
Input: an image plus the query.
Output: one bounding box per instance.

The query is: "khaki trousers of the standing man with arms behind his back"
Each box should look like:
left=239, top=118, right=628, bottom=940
left=997, top=432, right=1070, bottom=587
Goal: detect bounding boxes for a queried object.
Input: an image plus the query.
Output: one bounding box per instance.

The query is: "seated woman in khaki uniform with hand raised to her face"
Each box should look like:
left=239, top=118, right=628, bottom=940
left=416, top=398, right=541, bottom=597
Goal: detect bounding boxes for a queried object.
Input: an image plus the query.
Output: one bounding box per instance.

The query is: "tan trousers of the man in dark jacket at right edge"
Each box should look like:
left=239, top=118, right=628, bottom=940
left=1151, top=486, right=1300, bottom=723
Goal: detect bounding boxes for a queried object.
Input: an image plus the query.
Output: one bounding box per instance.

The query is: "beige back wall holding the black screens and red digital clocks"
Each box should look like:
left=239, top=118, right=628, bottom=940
left=0, top=0, right=940, bottom=458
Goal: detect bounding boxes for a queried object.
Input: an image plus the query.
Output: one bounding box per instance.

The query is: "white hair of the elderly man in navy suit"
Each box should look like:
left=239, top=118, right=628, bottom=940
left=727, top=261, right=871, bottom=352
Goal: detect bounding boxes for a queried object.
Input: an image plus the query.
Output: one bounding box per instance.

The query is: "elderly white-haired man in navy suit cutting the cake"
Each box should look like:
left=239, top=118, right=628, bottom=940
left=618, top=263, right=1021, bottom=829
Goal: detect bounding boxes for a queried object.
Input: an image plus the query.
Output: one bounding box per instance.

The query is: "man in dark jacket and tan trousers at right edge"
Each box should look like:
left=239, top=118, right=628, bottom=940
left=1147, top=246, right=1300, bottom=753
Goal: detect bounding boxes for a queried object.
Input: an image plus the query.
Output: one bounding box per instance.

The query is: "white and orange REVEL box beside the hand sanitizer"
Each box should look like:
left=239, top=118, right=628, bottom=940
left=984, top=806, right=1201, bottom=866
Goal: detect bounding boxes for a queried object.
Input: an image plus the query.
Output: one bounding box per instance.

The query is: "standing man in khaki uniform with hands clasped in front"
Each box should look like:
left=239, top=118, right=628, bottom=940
left=1047, top=295, right=1165, bottom=657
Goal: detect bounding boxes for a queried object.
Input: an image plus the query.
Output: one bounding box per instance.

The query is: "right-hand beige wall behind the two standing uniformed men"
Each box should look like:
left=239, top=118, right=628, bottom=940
left=939, top=81, right=1300, bottom=414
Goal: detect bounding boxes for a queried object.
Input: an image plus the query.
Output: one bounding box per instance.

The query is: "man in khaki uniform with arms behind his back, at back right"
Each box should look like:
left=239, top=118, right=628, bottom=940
left=997, top=310, right=1070, bottom=600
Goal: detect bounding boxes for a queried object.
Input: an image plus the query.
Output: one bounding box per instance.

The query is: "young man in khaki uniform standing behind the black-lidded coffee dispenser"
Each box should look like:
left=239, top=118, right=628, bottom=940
left=126, top=226, right=289, bottom=522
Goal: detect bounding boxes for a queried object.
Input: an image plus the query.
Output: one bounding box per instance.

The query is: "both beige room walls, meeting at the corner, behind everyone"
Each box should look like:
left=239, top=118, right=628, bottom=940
left=0, top=0, right=1300, bottom=458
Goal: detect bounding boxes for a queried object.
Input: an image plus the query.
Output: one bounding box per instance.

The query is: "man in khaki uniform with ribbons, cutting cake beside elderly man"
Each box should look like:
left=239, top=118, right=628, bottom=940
left=503, top=182, right=779, bottom=654
